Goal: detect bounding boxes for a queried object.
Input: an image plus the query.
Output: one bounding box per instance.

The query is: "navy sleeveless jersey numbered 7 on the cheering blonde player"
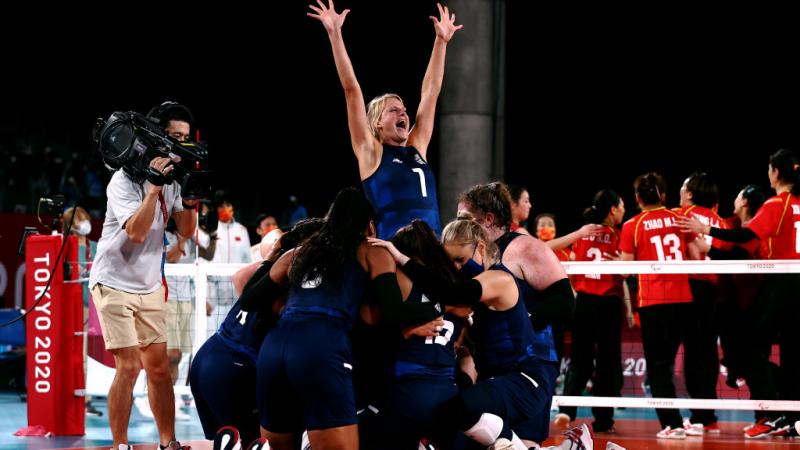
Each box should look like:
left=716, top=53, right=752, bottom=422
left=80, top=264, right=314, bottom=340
left=363, top=145, right=442, bottom=239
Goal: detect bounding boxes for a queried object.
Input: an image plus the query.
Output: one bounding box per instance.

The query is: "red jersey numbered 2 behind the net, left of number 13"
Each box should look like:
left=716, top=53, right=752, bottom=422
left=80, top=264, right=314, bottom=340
left=572, top=226, right=624, bottom=298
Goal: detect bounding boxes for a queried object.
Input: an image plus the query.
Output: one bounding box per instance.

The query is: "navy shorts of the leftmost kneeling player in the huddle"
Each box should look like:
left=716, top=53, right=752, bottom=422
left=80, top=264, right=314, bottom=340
left=189, top=334, right=261, bottom=443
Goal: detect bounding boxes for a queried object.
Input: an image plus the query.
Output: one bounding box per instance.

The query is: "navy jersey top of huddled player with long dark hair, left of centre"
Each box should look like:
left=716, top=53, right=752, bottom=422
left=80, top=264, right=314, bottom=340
left=281, top=260, right=368, bottom=330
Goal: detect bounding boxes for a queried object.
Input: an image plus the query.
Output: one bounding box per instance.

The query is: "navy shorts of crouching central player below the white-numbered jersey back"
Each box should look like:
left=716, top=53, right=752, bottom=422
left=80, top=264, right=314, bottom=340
left=358, top=379, right=460, bottom=450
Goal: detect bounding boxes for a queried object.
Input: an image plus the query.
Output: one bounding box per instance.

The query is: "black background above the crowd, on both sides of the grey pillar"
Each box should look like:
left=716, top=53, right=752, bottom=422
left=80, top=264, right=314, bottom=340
left=0, top=0, right=800, bottom=232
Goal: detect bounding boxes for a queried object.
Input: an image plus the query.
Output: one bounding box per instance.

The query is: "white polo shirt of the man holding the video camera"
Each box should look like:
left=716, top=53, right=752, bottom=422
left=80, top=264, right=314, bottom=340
left=89, top=170, right=183, bottom=294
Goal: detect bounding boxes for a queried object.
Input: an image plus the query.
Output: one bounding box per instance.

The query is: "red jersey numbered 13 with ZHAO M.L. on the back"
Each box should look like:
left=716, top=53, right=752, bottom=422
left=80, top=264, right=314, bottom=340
left=619, top=206, right=695, bottom=308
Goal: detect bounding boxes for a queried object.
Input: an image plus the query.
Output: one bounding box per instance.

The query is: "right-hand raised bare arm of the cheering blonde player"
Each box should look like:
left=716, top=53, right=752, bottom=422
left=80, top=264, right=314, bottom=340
left=408, top=3, right=464, bottom=158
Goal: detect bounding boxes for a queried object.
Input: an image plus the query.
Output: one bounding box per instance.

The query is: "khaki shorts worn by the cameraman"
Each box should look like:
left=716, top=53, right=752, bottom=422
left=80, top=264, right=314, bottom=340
left=92, top=284, right=167, bottom=350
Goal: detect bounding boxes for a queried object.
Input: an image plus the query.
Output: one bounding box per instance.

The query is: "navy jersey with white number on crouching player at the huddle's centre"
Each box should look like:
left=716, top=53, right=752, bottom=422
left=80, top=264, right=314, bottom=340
left=394, top=285, right=463, bottom=380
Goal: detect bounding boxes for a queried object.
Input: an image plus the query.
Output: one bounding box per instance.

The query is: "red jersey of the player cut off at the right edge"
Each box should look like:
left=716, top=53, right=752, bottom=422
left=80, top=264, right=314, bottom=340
left=746, top=192, right=800, bottom=259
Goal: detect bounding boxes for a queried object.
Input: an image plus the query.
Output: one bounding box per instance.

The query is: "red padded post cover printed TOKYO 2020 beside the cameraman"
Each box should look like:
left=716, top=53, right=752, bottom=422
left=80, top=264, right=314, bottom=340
left=25, top=235, right=85, bottom=436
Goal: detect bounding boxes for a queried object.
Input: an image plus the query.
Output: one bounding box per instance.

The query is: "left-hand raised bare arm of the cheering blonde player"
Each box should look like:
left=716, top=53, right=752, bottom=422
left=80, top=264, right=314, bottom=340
left=307, top=0, right=381, bottom=179
